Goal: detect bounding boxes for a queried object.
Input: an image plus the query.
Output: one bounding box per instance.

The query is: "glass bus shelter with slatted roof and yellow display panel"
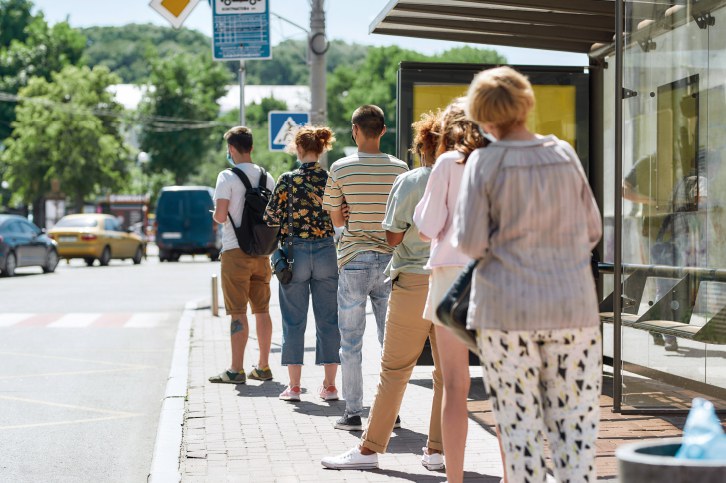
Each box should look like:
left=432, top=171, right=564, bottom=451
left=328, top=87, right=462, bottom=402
left=370, top=0, right=726, bottom=413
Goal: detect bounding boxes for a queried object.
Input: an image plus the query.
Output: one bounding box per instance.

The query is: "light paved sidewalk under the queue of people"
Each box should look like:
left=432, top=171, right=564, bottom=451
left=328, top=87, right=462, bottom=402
left=179, top=282, right=684, bottom=483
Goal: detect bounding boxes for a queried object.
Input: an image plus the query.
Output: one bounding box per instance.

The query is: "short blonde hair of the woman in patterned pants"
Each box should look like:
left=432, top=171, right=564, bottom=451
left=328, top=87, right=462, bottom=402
left=467, top=66, right=534, bottom=131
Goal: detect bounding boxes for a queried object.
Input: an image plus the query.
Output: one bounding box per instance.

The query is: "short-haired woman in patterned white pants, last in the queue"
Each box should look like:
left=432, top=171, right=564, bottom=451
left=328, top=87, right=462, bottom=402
left=454, top=67, right=602, bottom=483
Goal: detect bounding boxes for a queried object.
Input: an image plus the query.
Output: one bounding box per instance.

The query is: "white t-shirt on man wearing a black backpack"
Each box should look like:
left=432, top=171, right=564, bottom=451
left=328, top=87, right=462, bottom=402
left=214, top=163, right=275, bottom=252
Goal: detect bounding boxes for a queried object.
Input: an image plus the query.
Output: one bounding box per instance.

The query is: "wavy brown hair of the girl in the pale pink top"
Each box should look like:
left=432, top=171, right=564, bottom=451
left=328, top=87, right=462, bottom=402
left=436, top=97, right=489, bottom=163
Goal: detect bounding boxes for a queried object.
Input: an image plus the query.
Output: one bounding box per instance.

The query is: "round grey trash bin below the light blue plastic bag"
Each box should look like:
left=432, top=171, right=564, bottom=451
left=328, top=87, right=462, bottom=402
left=615, top=438, right=726, bottom=483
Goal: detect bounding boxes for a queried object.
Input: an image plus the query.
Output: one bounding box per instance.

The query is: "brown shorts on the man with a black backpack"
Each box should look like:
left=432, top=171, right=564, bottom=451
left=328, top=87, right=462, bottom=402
left=222, top=248, right=272, bottom=315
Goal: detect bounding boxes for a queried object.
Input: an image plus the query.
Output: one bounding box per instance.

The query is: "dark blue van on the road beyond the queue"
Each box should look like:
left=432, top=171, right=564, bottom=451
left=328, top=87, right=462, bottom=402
left=156, top=186, right=222, bottom=262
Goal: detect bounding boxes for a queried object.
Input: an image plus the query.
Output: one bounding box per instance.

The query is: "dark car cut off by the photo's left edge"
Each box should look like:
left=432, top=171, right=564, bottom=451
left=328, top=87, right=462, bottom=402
left=0, top=215, right=58, bottom=277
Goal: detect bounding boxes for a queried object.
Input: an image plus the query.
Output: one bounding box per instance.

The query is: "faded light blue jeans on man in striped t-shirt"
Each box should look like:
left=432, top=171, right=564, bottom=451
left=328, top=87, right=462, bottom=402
left=338, top=251, right=391, bottom=416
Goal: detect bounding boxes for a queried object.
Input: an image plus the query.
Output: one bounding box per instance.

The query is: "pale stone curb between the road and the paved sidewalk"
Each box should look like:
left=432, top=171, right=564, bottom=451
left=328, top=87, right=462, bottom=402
left=146, top=302, right=198, bottom=482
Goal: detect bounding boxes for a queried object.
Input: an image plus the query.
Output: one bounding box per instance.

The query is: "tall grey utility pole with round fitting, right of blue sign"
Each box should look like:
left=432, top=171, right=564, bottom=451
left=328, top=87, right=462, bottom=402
left=308, top=0, right=329, bottom=164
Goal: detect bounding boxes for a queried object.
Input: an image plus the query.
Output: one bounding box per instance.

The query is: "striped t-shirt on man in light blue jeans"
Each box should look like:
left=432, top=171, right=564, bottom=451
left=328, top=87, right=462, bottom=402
left=323, top=153, right=408, bottom=267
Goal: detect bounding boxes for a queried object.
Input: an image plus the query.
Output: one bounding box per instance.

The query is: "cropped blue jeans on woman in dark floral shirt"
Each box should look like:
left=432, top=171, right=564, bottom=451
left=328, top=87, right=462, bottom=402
left=279, top=237, right=340, bottom=366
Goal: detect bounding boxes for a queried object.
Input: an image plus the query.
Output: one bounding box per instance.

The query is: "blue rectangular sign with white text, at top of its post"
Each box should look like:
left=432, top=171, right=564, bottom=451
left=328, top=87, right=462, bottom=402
left=212, top=0, right=271, bottom=60
